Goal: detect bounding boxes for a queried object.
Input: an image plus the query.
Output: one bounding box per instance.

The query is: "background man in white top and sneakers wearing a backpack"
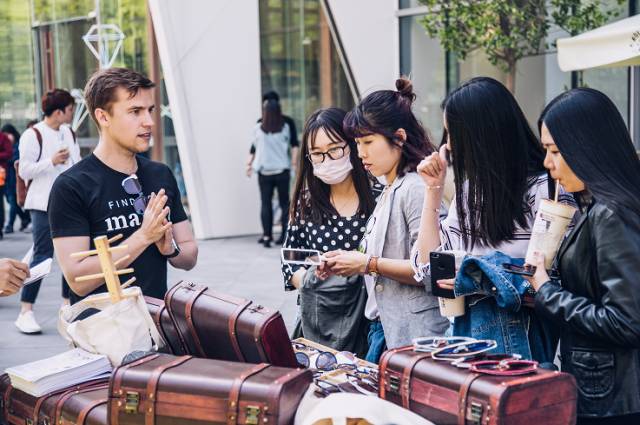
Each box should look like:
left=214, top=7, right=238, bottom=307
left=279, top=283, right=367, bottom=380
left=15, top=89, right=80, bottom=334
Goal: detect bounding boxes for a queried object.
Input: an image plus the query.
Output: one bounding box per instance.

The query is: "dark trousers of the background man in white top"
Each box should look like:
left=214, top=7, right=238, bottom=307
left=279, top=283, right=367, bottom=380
left=20, top=210, right=69, bottom=304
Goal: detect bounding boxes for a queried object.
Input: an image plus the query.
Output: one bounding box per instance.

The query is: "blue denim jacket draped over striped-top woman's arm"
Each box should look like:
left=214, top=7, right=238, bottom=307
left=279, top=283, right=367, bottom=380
left=453, top=251, right=558, bottom=363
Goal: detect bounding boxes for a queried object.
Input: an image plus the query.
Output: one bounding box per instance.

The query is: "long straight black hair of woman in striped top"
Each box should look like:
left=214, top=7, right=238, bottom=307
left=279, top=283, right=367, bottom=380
left=442, top=77, right=545, bottom=248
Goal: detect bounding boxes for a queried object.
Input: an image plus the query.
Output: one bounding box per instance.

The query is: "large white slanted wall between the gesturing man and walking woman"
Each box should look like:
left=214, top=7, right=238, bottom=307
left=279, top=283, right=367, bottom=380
left=149, top=0, right=260, bottom=239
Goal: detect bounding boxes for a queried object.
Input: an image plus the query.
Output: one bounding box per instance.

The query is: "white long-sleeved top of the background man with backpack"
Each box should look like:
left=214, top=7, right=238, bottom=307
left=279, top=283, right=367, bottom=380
left=19, top=121, right=80, bottom=211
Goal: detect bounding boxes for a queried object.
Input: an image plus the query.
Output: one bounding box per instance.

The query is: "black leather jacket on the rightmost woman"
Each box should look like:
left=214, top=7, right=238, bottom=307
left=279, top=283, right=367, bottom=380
left=536, top=202, right=640, bottom=414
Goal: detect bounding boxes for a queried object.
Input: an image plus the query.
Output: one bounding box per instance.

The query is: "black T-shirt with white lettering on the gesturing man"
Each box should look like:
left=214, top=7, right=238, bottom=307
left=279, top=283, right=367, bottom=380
left=48, top=155, right=187, bottom=303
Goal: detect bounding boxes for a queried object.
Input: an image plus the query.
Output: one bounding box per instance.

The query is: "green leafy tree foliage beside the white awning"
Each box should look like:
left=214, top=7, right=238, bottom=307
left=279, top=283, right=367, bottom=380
left=420, top=0, right=624, bottom=92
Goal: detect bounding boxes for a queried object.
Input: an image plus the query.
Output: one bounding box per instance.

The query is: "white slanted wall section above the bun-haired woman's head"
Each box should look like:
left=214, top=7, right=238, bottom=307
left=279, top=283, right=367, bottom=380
left=328, top=0, right=400, bottom=95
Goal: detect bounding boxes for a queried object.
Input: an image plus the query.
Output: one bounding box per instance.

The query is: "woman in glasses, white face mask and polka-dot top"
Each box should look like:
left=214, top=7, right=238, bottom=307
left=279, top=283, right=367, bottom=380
left=282, top=108, right=380, bottom=353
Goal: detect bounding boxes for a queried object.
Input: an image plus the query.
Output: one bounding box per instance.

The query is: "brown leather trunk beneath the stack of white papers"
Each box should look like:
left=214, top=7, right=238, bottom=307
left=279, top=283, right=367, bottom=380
left=0, top=374, right=109, bottom=425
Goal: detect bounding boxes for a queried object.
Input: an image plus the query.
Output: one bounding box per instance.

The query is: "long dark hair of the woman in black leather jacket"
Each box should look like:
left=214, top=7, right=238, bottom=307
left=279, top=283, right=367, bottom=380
left=538, top=88, right=640, bottom=217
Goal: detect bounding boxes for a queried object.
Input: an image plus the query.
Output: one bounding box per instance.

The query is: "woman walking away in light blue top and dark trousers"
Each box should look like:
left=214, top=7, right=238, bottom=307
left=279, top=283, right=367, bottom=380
left=247, top=99, right=297, bottom=248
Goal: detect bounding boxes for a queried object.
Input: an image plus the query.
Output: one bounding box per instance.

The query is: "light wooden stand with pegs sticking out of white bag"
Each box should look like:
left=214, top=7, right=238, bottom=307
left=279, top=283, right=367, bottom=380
left=71, top=234, right=136, bottom=304
